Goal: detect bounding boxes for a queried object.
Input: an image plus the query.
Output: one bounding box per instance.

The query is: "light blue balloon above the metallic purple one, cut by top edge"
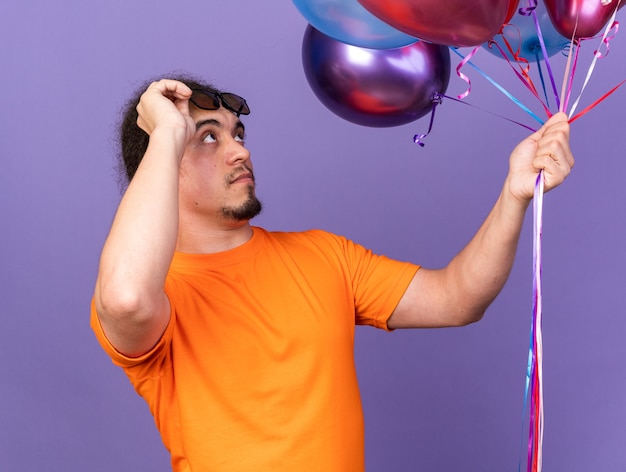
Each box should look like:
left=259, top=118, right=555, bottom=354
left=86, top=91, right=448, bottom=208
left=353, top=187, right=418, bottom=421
left=293, top=0, right=417, bottom=49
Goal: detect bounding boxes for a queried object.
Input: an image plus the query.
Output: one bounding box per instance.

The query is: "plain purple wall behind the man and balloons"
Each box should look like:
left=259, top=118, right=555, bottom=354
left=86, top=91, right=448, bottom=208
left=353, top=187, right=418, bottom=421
left=0, top=0, right=626, bottom=472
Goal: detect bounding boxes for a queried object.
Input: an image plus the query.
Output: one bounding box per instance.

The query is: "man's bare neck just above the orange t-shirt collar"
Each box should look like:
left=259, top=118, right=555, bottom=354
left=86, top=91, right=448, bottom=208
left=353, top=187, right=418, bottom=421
left=176, top=221, right=252, bottom=254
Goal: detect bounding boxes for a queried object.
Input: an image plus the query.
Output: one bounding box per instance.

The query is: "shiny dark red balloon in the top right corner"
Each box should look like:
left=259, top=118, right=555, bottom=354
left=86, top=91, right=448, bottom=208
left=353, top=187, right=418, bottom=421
left=544, top=0, right=626, bottom=39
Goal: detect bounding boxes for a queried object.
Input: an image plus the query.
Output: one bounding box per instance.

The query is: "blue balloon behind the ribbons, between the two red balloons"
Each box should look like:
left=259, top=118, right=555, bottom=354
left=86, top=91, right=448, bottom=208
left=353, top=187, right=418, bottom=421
left=483, top=0, right=570, bottom=61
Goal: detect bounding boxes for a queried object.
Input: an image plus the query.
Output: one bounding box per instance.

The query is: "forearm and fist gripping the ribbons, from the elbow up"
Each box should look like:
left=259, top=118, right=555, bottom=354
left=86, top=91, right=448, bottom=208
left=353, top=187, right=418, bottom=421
left=446, top=113, right=574, bottom=319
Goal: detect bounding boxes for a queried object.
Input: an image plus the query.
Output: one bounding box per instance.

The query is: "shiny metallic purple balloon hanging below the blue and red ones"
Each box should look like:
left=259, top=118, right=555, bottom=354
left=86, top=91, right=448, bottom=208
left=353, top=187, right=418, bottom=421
left=302, top=25, right=450, bottom=128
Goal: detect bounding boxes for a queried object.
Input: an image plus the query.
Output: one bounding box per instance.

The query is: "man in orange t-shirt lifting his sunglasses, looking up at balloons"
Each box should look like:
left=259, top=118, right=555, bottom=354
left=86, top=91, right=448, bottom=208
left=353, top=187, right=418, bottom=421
left=91, top=74, right=574, bottom=472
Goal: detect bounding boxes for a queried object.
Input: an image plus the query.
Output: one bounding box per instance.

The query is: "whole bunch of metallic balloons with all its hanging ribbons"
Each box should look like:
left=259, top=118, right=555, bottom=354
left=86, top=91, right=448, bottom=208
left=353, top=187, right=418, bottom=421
left=293, top=0, right=626, bottom=472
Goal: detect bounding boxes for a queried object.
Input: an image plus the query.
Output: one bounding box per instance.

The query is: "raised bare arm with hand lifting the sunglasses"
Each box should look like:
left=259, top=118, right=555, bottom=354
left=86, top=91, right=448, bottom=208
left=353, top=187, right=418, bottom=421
left=94, top=80, right=194, bottom=356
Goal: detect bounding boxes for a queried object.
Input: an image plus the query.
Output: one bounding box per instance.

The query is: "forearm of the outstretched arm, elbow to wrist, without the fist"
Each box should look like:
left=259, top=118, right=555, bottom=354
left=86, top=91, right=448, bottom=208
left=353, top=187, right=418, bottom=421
left=444, top=184, right=528, bottom=324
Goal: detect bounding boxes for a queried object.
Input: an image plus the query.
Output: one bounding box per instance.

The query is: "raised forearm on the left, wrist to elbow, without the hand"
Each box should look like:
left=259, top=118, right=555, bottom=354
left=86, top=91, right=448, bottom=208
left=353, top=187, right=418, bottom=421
left=96, top=130, right=183, bottom=311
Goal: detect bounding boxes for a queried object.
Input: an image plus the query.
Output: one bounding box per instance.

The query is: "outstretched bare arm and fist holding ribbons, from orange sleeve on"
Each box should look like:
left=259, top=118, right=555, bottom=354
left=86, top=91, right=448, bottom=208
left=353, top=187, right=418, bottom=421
left=388, top=113, right=574, bottom=328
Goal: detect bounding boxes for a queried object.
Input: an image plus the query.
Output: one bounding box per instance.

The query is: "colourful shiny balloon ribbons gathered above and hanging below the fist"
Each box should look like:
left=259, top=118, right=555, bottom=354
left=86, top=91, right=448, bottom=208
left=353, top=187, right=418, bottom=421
left=434, top=4, right=626, bottom=472
